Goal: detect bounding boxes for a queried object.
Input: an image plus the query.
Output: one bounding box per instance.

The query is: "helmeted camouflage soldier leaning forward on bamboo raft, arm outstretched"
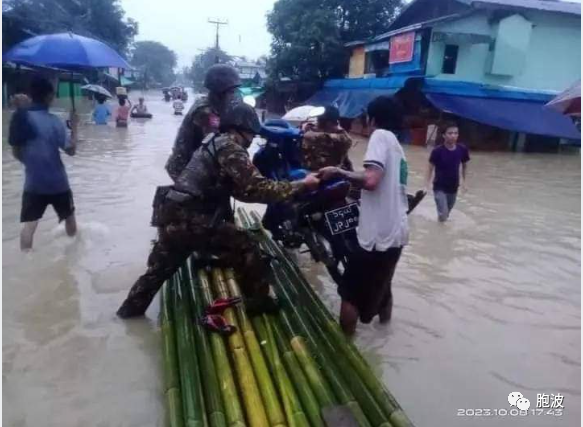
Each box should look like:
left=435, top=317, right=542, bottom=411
left=117, top=103, right=318, bottom=318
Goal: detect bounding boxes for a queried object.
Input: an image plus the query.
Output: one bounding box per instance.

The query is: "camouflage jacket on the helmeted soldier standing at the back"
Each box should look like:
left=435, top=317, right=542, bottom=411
left=166, top=97, right=219, bottom=181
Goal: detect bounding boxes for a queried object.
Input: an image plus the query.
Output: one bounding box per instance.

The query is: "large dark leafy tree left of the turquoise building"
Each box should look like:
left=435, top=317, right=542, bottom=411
left=267, top=0, right=402, bottom=81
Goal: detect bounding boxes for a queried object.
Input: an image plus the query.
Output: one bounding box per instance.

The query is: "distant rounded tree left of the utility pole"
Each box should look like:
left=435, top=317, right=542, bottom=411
left=130, top=41, right=177, bottom=86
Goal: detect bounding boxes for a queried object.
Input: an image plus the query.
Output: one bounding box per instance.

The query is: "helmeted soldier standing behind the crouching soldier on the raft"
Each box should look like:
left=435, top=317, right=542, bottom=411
left=166, top=64, right=241, bottom=181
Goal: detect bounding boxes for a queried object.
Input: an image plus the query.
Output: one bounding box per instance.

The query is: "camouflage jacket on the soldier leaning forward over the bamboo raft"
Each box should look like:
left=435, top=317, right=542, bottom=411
left=174, top=134, right=301, bottom=211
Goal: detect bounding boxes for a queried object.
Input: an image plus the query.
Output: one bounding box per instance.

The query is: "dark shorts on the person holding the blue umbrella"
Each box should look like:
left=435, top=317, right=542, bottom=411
left=20, top=190, right=75, bottom=222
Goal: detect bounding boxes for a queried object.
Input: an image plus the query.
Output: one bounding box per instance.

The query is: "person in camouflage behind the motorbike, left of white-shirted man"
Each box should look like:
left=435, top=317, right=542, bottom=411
left=302, top=106, right=352, bottom=171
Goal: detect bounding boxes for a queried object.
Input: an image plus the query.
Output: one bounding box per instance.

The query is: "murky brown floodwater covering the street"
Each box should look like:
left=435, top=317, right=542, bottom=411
left=2, top=92, right=581, bottom=427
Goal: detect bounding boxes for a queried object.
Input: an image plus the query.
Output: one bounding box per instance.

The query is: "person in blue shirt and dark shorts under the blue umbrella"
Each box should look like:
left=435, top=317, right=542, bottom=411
left=8, top=77, right=79, bottom=251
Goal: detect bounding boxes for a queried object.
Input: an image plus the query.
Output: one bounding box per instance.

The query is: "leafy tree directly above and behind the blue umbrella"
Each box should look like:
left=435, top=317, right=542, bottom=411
left=2, top=0, right=138, bottom=56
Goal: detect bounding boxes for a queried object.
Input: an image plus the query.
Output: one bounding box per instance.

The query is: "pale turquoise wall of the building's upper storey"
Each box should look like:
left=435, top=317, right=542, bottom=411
left=427, top=12, right=581, bottom=91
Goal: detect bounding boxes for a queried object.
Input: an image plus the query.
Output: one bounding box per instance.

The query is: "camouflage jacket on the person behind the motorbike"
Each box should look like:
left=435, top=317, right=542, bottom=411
left=302, top=130, right=352, bottom=171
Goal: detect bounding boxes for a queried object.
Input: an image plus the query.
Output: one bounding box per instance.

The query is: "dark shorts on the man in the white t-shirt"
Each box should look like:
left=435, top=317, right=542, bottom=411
left=338, top=247, right=403, bottom=323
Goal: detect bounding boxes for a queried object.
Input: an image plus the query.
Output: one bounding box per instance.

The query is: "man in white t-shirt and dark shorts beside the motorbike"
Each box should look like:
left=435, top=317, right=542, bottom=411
left=319, top=96, right=409, bottom=335
